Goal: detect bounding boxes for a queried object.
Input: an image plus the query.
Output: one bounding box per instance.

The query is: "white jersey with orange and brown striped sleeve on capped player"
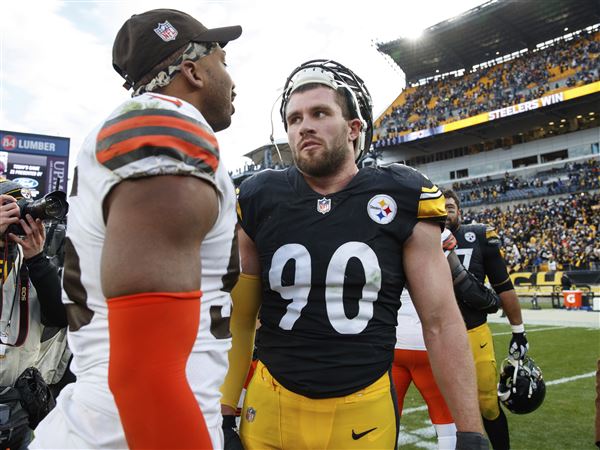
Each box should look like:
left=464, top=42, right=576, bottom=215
left=34, top=93, right=239, bottom=448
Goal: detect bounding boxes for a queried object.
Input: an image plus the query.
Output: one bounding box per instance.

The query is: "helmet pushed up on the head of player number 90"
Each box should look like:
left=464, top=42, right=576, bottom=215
left=279, top=59, right=373, bottom=161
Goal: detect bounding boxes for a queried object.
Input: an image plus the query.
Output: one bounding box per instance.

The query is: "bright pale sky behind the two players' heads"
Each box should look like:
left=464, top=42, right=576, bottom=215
left=0, top=0, right=483, bottom=174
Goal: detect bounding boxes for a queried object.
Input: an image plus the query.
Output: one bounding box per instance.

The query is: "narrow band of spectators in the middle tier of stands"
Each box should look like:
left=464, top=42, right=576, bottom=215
left=452, top=159, right=600, bottom=206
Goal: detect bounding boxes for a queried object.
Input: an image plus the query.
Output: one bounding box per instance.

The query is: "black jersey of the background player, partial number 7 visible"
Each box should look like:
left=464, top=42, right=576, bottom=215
left=453, top=223, right=513, bottom=330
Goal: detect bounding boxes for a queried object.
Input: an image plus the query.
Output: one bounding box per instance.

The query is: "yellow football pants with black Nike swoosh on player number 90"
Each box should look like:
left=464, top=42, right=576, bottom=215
left=240, top=361, right=398, bottom=450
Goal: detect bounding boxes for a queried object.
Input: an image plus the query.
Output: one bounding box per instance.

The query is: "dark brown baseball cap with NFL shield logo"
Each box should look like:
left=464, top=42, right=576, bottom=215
left=113, top=9, right=242, bottom=89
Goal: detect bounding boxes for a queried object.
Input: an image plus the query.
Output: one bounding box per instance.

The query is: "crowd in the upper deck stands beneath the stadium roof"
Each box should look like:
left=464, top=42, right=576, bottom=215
left=375, top=31, right=600, bottom=145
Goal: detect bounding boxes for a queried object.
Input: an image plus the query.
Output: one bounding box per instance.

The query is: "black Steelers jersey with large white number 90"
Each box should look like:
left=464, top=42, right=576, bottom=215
left=238, top=164, right=446, bottom=398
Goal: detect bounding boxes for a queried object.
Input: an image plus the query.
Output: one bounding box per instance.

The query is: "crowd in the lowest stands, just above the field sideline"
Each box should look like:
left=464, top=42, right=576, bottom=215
left=464, top=187, right=600, bottom=272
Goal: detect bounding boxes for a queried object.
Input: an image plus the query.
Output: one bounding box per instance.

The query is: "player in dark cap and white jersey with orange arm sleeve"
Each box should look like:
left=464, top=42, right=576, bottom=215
left=32, top=9, right=241, bottom=448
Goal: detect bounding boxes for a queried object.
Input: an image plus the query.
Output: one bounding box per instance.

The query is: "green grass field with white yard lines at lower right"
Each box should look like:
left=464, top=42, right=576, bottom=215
left=399, top=323, right=600, bottom=450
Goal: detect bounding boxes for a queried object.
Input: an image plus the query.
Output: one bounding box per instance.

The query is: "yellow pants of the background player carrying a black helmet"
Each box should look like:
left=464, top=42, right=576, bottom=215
left=467, top=323, right=500, bottom=420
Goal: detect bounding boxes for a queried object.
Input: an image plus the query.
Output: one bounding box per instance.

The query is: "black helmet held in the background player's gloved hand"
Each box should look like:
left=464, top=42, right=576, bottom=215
left=498, top=357, right=546, bottom=414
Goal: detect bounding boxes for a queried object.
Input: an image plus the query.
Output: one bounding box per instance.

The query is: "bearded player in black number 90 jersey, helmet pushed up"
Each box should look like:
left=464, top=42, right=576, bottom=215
left=222, top=60, right=487, bottom=449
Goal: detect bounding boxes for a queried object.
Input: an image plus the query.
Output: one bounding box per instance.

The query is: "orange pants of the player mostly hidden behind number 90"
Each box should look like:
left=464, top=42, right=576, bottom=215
left=392, top=349, right=454, bottom=425
